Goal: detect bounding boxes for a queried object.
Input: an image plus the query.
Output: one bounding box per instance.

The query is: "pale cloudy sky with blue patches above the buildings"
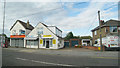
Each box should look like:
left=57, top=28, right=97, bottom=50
left=0, top=0, right=118, bottom=37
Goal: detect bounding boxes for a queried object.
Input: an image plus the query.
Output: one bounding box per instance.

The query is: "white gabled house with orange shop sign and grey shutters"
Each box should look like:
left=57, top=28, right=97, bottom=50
left=10, top=20, right=34, bottom=47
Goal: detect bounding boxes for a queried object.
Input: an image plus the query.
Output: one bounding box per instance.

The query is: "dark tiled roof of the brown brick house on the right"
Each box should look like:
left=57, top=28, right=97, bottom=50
left=91, top=19, right=120, bottom=32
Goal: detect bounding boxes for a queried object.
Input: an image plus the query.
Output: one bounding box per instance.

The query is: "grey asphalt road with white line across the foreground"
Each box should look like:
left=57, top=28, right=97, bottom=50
left=2, top=49, right=118, bottom=67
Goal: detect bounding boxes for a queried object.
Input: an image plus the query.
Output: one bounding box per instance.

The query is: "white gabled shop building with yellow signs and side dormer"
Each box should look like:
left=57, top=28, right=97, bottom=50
left=25, top=23, right=64, bottom=49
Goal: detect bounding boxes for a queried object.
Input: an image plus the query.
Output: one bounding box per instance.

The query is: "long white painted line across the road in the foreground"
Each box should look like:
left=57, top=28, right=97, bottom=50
left=16, top=58, right=75, bottom=66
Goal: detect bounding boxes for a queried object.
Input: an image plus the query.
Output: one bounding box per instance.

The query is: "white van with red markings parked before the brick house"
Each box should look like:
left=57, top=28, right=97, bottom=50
left=94, top=36, right=120, bottom=50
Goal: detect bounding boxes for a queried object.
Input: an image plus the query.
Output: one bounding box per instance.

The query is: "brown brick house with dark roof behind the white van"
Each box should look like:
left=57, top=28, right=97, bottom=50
left=91, top=19, right=120, bottom=44
